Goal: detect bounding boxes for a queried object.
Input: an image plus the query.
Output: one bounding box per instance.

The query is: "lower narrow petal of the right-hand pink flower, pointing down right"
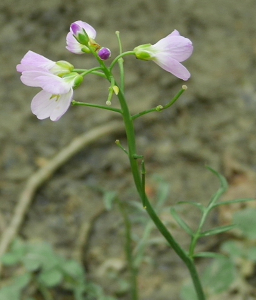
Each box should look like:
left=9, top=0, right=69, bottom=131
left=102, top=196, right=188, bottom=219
left=154, top=53, right=190, bottom=81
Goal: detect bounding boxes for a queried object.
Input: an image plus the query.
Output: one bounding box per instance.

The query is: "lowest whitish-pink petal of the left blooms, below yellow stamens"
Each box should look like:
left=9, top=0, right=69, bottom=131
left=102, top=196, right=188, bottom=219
left=31, top=89, right=73, bottom=121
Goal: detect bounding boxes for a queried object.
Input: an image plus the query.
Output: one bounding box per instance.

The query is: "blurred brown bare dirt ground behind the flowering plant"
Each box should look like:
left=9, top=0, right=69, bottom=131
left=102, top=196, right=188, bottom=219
left=0, top=0, right=256, bottom=300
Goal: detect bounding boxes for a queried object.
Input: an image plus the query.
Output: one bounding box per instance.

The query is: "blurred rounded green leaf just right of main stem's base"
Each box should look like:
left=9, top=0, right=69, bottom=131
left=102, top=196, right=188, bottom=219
left=202, top=257, right=236, bottom=294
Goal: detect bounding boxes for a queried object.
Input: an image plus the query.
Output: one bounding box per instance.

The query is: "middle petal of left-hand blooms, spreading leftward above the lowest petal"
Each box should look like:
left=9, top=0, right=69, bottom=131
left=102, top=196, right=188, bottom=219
left=20, top=71, right=72, bottom=94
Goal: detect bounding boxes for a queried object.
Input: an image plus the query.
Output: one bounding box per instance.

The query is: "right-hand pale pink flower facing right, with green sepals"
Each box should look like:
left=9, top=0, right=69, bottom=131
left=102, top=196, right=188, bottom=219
left=134, top=30, right=193, bottom=80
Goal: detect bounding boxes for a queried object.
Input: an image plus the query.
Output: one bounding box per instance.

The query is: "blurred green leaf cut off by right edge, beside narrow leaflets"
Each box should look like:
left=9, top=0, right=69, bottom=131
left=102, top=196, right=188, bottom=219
left=233, top=208, right=256, bottom=239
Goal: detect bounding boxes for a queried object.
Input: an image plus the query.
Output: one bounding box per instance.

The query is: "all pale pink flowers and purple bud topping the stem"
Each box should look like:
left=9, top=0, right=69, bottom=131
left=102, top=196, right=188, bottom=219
left=17, top=21, right=193, bottom=121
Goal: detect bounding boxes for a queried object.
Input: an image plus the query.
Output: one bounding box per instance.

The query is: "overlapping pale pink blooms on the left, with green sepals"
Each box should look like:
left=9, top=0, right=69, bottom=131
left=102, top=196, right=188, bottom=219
left=17, top=51, right=83, bottom=121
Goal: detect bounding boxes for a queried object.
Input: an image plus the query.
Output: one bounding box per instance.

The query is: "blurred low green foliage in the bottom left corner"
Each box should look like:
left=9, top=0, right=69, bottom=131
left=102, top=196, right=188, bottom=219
left=0, top=240, right=116, bottom=300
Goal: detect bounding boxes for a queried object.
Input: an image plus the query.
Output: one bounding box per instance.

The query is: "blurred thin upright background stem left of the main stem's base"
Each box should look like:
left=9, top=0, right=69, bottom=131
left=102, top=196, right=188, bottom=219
left=117, top=199, right=139, bottom=300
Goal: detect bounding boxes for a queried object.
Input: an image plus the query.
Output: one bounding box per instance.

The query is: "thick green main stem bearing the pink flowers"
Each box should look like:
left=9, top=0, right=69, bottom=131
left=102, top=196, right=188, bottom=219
left=118, top=90, right=205, bottom=300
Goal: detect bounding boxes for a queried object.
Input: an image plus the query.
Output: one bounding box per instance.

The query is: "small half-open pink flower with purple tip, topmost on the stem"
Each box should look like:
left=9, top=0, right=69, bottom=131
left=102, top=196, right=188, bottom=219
left=66, top=21, right=96, bottom=54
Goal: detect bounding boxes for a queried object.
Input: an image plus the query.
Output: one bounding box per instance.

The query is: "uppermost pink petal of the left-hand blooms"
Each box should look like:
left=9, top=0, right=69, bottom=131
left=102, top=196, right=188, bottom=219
left=16, top=51, right=55, bottom=72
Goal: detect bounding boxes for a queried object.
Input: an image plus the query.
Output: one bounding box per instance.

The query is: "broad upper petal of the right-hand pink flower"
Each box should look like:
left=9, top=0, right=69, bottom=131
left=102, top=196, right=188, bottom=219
left=152, top=33, right=193, bottom=62
